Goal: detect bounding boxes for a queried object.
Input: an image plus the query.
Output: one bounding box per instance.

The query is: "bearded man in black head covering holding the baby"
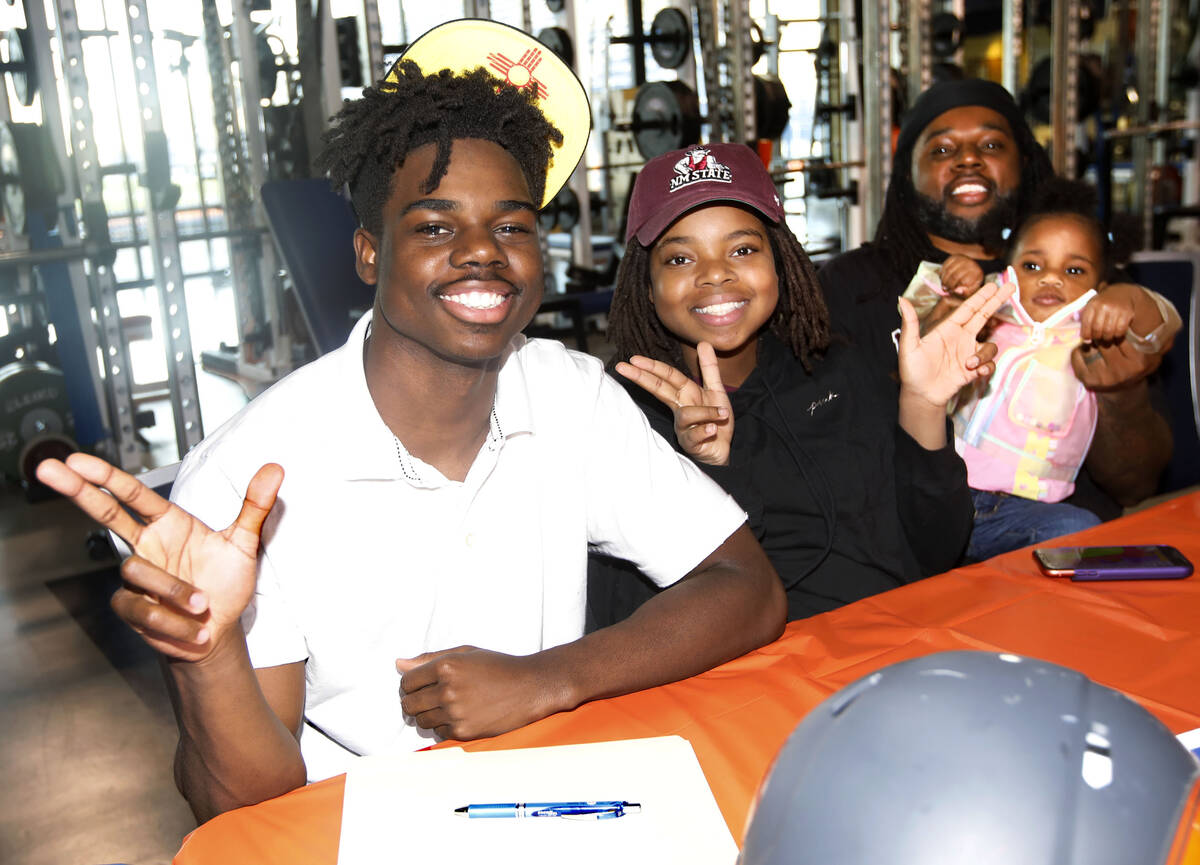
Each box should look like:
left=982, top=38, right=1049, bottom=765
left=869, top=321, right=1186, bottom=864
left=818, top=79, right=1172, bottom=519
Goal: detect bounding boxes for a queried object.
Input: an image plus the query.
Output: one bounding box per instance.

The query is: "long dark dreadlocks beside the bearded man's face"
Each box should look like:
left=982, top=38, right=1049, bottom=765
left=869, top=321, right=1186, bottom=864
left=872, top=103, right=1054, bottom=281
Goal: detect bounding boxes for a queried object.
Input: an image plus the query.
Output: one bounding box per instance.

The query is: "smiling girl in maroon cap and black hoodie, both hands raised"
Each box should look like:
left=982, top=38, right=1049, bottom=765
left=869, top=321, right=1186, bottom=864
left=588, top=144, right=1007, bottom=625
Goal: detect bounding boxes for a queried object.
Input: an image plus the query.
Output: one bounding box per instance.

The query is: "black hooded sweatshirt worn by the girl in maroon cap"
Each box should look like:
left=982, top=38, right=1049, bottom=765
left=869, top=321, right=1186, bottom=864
left=588, top=334, right=973, bottom=626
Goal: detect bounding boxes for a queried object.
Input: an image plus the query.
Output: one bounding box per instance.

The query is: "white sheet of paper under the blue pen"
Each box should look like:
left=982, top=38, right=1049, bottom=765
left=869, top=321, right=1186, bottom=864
left=337, top=737, right=738, bottom=865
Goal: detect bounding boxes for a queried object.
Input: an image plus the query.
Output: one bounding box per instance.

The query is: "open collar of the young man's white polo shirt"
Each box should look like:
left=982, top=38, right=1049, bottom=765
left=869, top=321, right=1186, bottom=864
left=319, top=311, right=534, bottom=480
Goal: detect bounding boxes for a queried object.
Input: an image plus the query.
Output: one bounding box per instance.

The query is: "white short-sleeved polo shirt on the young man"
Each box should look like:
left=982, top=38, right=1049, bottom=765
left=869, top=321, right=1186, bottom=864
left=172, top=313, right=745, bottom=780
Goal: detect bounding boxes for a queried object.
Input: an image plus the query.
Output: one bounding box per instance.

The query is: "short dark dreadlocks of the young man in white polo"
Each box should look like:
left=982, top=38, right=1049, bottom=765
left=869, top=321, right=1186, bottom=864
left=316, top=60, right=563, bottom=234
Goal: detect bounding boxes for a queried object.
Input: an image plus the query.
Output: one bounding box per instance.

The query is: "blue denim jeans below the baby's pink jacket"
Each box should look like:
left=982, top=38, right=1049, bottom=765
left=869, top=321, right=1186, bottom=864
left=967, top=489, right=1100, bottom=561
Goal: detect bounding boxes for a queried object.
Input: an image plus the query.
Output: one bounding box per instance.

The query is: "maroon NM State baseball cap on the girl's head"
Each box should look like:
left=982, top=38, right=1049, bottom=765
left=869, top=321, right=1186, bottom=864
left=625, top=144, right=784, bottom=246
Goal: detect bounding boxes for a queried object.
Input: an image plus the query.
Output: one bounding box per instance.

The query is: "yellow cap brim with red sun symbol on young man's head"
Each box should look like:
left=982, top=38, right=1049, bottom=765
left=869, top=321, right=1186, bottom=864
left=384, top=18, right=592, bottom=208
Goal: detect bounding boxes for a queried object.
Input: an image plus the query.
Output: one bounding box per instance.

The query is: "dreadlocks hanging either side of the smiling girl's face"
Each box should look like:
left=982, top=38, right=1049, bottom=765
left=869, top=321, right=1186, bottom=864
left=608, top=220, right=829, bottom=372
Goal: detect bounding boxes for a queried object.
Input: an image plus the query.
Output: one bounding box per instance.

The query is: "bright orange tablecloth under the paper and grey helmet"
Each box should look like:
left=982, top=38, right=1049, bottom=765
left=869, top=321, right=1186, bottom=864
left=175, top=493, right=1200, bottom=865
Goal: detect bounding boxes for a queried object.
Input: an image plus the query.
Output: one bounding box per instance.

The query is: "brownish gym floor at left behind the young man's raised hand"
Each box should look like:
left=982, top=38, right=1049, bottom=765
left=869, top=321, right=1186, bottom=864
left=0, top=367, right=255, bottom=865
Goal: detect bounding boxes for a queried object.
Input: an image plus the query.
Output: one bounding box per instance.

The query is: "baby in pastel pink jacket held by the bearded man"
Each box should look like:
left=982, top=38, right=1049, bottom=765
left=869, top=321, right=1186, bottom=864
left=905, top=180, right=1181, bottom=559
